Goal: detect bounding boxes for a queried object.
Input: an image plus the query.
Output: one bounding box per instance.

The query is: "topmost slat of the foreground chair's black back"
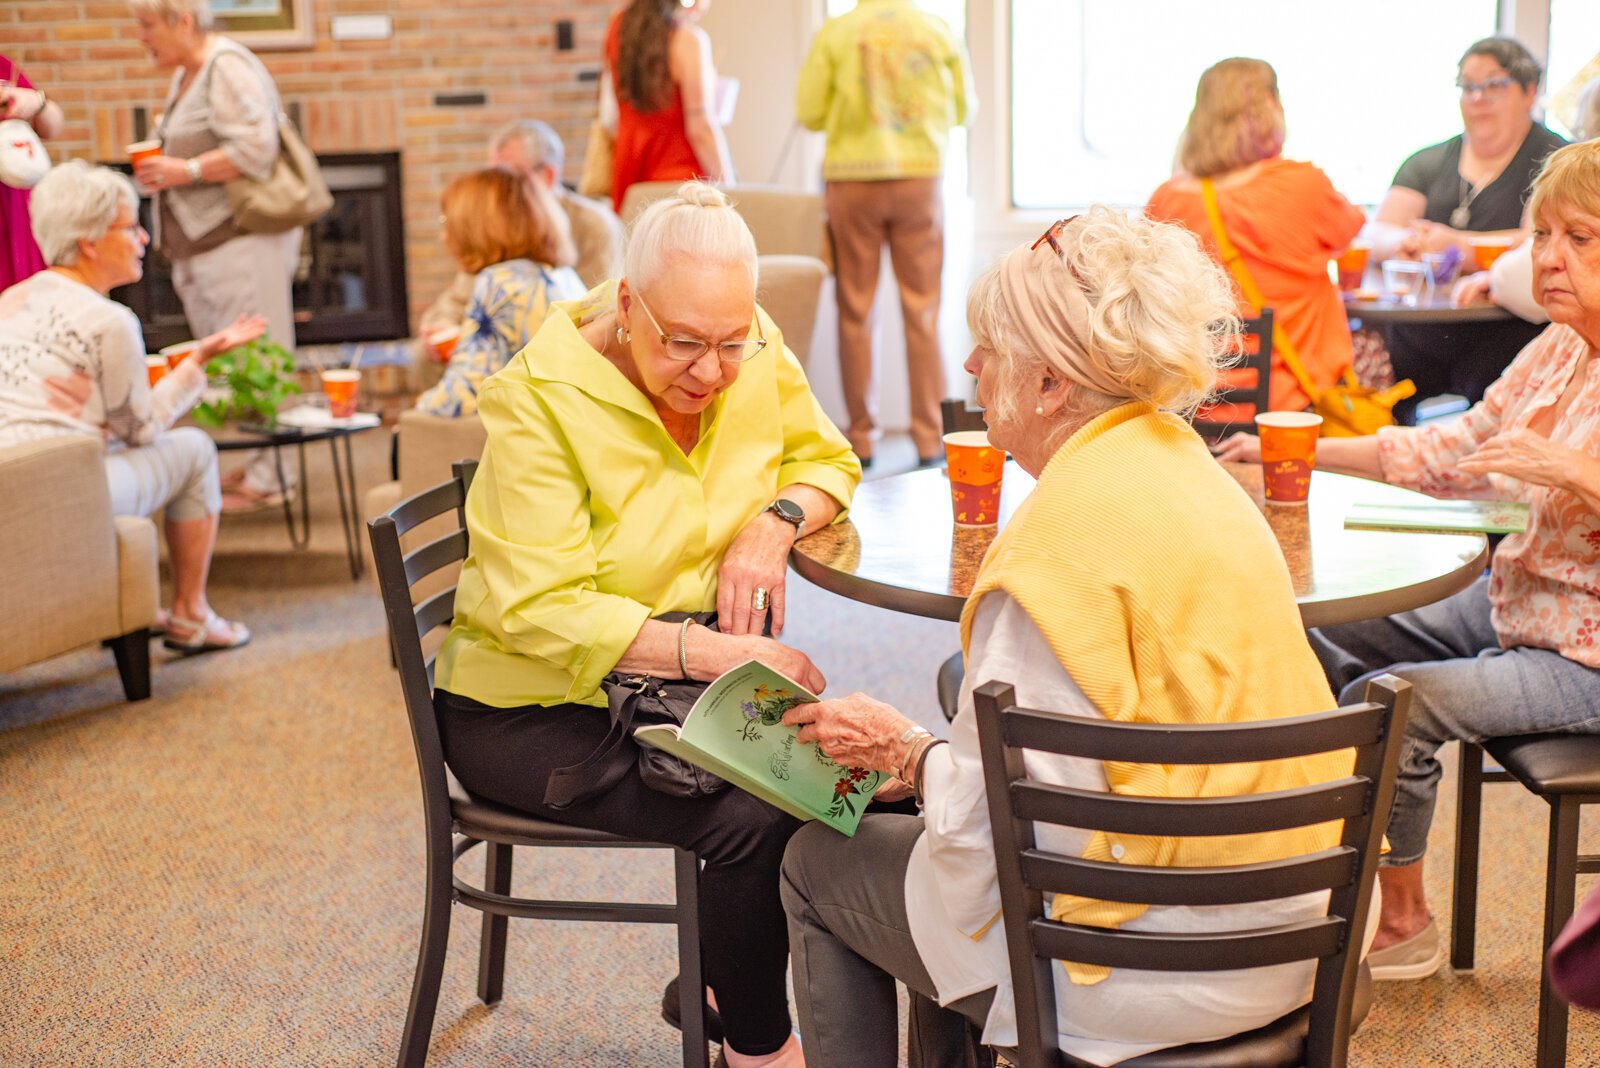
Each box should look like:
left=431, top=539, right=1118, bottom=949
left=1005, top=702, right=1387, bottom=764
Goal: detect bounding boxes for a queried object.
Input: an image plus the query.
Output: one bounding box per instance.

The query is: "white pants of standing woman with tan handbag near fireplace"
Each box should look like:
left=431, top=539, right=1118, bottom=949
left=173, top=230, right=304, bottom=494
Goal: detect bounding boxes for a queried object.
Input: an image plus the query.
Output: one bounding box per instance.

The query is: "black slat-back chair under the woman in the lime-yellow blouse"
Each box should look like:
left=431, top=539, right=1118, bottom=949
left=366, top=460, right=707, bottom=1068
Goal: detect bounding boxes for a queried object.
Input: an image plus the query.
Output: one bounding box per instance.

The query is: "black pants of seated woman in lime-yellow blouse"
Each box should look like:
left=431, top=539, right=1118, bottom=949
left=434, top=691, right=800, bottom=1055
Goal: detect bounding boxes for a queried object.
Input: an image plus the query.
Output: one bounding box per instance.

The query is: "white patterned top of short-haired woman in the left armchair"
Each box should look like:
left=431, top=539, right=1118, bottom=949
left=0, top=270, right=205, bottom=449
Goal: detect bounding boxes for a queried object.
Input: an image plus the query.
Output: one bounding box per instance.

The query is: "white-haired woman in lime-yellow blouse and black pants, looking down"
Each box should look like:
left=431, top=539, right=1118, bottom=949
left=435, top=182, right=861, bottom=1068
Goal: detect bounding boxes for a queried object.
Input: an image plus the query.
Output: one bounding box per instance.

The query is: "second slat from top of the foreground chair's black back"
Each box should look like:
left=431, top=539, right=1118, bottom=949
left=1011, top=777, right=1370, bottom=838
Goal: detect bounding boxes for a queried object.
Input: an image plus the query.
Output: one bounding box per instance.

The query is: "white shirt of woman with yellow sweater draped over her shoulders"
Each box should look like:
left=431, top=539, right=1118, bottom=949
left=906, top=592, right=1378, bottom=1065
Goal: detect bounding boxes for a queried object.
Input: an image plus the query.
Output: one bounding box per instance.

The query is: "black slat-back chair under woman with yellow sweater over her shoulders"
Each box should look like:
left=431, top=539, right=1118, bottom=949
left=974, top=676, right=1411, bottom=1068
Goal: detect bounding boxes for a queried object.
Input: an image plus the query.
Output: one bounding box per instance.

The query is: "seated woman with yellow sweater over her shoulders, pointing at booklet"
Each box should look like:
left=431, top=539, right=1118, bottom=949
left=782, top=208, right=1371, bottom=1068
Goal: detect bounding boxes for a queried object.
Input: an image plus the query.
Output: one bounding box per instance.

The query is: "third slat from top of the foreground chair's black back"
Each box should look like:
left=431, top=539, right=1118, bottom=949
left=1022, top=846, right=1360, bottom=905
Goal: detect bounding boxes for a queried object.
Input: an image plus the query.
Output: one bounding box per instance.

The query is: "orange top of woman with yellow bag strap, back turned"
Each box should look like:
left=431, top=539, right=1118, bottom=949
left=1144, top=158, right=1366, bottom=411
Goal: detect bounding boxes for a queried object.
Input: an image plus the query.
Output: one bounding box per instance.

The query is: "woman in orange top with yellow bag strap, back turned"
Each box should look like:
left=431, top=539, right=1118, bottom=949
left=1144, top=58, right=1366, bottom=417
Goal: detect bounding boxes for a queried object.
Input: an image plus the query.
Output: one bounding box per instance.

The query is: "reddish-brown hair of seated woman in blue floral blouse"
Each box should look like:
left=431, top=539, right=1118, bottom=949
left=440, top=166, right=574, bottom=273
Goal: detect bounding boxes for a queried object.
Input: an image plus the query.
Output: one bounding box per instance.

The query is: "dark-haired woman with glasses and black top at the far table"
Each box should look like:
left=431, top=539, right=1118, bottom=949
left=1373, top=37, right=1566, bottom=422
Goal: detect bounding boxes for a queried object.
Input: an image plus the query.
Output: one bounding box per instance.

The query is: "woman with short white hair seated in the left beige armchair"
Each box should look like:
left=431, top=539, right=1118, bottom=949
left=0, top=160, right=266, bottom=652
